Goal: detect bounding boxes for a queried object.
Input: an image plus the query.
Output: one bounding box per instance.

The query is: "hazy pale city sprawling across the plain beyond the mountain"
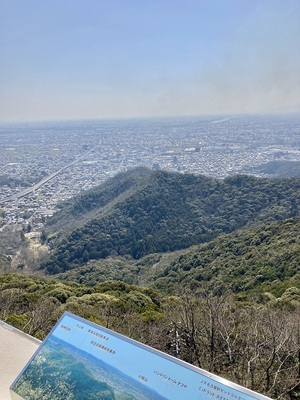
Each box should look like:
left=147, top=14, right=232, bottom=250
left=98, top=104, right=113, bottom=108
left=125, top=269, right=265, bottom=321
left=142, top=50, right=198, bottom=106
left=0, top=114, right=300, bottom=230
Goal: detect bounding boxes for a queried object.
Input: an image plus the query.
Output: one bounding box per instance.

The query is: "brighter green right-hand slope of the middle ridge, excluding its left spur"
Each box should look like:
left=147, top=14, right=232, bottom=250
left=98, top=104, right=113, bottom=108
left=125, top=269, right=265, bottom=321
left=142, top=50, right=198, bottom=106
left=143, top=217, right=300, bottom=297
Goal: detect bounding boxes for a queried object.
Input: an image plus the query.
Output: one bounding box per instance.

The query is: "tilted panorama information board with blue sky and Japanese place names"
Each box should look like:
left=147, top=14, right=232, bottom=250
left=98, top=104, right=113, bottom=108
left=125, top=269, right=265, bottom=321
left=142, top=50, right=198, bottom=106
left=11, top=312, right=269, bottom=400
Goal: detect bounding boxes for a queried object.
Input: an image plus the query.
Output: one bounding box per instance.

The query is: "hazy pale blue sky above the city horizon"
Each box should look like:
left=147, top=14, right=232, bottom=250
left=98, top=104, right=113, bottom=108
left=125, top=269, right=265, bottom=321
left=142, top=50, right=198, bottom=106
left=0, top=0, right=300, bottom=121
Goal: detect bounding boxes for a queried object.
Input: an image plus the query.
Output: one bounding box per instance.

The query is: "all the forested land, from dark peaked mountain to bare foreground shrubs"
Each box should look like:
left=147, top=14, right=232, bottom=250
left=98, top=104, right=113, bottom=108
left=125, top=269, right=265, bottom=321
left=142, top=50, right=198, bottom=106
left=0, top=168, right=300, bottom=400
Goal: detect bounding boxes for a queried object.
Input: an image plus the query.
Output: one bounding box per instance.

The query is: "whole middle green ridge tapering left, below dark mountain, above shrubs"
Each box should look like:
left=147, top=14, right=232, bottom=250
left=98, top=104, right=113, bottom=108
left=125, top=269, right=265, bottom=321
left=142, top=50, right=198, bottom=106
left=57, top=217, right=300, bottom=298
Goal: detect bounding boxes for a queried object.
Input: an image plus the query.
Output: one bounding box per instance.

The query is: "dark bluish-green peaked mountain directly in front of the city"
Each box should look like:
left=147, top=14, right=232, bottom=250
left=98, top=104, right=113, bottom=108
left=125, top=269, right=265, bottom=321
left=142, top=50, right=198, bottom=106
left=42, top=168, right=300, bottom=274
